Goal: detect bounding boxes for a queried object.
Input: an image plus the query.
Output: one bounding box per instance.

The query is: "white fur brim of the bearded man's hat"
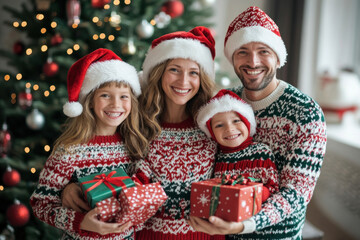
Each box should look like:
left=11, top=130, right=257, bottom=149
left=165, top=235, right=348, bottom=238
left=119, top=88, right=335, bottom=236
left=224, top=26, right=287, bottom=67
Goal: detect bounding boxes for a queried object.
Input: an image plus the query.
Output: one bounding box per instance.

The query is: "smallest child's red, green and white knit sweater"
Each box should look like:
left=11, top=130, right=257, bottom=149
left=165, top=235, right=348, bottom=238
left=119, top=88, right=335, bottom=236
left=214, top=142, right=279, bottom=194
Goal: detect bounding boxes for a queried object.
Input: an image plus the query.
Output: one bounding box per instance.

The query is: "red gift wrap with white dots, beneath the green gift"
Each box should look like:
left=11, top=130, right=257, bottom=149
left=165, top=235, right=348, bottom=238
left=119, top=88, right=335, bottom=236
left=96, top=183, right=167, bottom=225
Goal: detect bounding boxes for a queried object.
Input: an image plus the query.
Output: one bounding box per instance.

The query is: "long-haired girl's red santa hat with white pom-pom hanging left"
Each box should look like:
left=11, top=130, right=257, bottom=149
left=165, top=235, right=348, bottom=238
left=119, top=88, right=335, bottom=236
left=63, top=48, right=141, bottom=117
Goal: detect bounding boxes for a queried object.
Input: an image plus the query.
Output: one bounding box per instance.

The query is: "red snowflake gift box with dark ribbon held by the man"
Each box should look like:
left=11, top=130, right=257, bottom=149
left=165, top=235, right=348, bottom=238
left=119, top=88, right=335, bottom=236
left=190, top=175, right=263, bottom=222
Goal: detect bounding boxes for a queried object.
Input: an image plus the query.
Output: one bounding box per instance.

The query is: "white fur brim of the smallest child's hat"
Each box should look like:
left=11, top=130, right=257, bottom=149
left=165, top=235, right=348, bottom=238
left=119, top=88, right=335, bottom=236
left=196, top=95, right=256, bottom=138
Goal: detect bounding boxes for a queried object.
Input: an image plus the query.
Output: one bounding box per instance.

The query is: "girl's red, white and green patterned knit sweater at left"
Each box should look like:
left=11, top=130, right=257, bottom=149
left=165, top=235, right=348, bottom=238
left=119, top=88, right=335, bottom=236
left=30, top=134, right=134, bottom=240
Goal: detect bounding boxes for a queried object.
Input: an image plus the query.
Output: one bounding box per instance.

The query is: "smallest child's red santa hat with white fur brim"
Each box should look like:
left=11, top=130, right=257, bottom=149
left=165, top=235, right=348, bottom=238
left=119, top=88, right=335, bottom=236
left=196, top=89, right=256, bottom=139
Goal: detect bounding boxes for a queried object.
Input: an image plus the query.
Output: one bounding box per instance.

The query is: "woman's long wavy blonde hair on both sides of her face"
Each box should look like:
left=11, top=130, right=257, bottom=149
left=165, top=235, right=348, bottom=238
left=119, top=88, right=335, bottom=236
left=139, top=59, right=215, bottom=141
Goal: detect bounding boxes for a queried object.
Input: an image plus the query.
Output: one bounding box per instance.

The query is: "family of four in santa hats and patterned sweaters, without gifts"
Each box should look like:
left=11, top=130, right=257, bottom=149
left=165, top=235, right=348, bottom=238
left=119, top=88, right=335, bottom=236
left=30, top=6, right=326, bottom=240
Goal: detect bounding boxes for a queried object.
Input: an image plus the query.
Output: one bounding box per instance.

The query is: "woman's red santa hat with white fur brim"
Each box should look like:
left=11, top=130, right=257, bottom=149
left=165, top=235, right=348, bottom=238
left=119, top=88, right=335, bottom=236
left=140, top=26, right=215, bottom=85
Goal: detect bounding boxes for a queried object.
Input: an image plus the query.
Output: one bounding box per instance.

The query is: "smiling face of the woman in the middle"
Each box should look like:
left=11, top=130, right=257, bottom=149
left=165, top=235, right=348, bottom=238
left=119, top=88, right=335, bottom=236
left=161, top=58, right=200, bottom=108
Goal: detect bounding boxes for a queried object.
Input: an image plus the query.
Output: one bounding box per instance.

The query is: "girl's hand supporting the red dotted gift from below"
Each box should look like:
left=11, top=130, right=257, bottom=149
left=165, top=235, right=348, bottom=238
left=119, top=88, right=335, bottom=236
left=80, top=208, right=132, bottom=235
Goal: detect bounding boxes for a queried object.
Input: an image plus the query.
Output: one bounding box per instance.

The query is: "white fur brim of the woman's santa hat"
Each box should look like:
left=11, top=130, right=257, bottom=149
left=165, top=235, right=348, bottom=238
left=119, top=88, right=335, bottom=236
left=142, top=38, right=215, bottom=83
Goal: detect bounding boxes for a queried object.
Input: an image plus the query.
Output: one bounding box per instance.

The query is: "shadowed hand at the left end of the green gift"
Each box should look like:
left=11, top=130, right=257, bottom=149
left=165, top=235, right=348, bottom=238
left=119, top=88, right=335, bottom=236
left=61, top=183, right=91, bottom=212
